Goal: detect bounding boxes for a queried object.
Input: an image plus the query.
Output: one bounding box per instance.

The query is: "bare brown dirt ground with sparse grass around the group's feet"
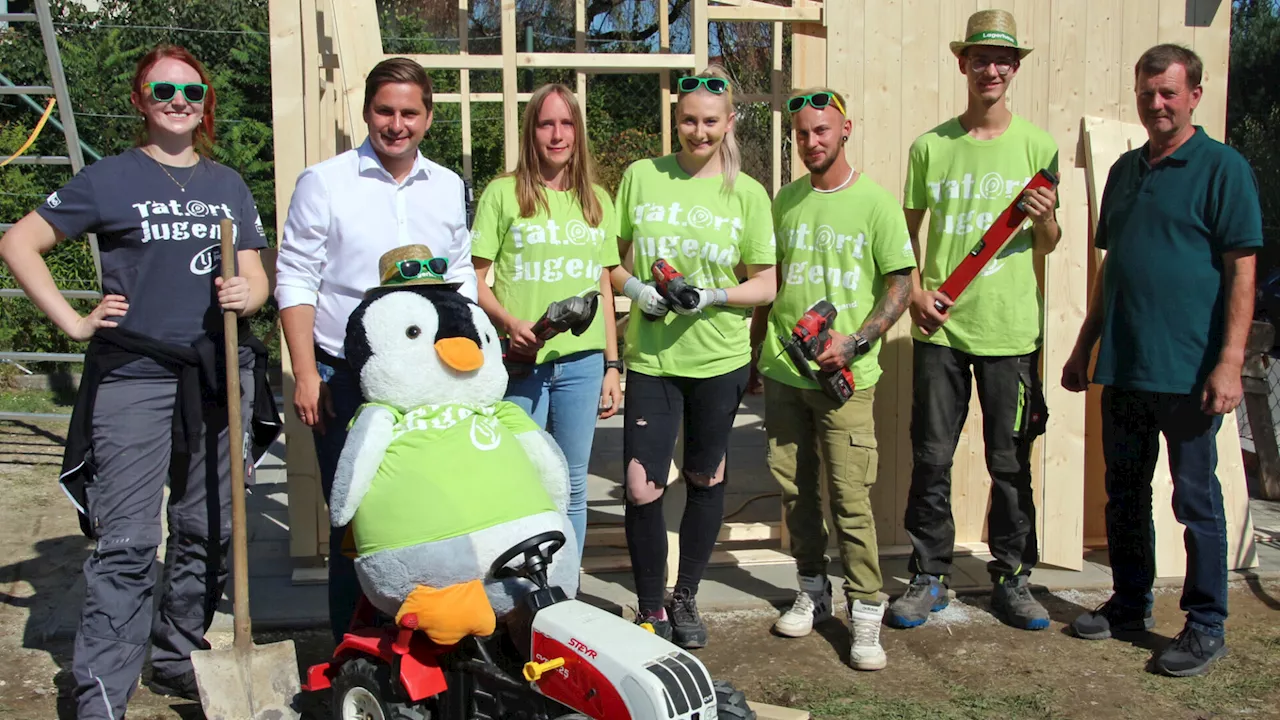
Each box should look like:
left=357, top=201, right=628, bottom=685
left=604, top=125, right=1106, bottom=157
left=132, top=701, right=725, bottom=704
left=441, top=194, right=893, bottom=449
left=0, top=421, right=1280, bottom=720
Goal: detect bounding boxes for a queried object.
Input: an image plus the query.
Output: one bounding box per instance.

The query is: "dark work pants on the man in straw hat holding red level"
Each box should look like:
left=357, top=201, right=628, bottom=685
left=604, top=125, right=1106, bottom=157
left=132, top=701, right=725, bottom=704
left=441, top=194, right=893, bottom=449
left=905, top=341, right=1047, bottom=582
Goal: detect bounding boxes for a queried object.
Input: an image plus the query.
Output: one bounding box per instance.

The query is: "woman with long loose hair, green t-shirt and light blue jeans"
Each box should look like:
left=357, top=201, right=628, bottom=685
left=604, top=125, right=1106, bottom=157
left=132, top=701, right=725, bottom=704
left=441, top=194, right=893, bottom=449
left=471, top=83, right=622, bottom=553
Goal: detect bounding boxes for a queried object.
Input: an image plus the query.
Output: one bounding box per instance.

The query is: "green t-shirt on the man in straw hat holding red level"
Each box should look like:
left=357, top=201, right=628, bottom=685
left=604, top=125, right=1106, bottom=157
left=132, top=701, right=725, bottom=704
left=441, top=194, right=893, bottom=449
left=902, top=115, right=1057, bottom=356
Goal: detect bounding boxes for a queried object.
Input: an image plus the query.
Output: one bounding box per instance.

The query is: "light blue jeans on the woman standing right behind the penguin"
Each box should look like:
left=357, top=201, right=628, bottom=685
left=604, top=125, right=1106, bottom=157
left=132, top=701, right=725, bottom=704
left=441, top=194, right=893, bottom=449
left=507, top=350, right=604, bottom=555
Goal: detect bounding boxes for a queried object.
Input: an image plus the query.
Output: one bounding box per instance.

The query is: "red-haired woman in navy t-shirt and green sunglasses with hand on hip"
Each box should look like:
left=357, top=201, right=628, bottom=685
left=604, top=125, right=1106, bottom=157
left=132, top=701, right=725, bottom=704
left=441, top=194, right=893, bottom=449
left=0, top=46, right=278, bottom=720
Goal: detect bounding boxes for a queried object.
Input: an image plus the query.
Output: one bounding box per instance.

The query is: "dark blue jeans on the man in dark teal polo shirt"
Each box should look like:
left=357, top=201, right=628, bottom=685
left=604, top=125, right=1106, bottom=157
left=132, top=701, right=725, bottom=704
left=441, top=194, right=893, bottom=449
left=1102, top=387, right=1226, bottom=637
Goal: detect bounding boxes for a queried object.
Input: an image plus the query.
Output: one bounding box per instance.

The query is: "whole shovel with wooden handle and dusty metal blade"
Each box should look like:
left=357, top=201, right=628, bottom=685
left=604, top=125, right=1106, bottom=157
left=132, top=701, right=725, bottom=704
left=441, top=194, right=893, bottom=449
left=191, top=219, right=301, bottom=720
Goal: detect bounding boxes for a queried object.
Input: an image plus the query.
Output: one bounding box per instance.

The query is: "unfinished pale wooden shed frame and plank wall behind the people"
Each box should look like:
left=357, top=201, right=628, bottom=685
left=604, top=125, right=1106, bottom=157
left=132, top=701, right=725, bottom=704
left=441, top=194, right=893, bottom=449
left=270, top=0, right=1256, bottom=584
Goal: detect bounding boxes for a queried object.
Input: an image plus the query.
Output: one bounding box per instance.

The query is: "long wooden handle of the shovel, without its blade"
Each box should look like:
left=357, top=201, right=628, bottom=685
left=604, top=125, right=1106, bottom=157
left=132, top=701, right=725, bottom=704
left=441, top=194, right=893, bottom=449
left=219, top=218, right=253, bottom=650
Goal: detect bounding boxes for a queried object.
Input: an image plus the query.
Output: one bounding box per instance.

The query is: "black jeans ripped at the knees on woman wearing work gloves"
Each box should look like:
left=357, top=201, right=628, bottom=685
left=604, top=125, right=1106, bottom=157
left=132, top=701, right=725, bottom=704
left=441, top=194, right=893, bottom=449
left=622, top=365, right=749, bottom=614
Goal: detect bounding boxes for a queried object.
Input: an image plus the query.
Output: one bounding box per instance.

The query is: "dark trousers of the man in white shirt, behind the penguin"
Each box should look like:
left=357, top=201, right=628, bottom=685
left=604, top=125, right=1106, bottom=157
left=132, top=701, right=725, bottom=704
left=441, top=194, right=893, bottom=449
left=311, top=347, right=365, bottom=642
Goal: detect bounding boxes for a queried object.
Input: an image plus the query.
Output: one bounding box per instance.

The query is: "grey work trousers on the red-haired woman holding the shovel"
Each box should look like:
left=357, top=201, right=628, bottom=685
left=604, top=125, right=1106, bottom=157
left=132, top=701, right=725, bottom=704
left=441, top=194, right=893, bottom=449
left=72, top=368, right=253, bottom=720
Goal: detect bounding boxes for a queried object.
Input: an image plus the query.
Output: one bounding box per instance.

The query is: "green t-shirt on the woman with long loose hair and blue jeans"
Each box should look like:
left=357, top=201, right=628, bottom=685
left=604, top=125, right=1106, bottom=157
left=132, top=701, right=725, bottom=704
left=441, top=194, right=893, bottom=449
left=471, top=176, right=618, bottom=363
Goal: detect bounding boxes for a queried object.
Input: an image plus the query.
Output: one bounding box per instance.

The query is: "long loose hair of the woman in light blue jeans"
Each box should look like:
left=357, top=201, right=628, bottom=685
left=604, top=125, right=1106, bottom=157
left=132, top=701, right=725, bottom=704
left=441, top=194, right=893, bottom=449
left=509, top=83, right=604, bottom=228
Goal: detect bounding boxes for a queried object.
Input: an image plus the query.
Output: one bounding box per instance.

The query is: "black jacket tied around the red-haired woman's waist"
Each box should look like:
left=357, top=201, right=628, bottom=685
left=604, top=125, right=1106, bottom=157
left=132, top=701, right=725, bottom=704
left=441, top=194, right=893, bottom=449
left=59, top=322, right=282, bottom=538
